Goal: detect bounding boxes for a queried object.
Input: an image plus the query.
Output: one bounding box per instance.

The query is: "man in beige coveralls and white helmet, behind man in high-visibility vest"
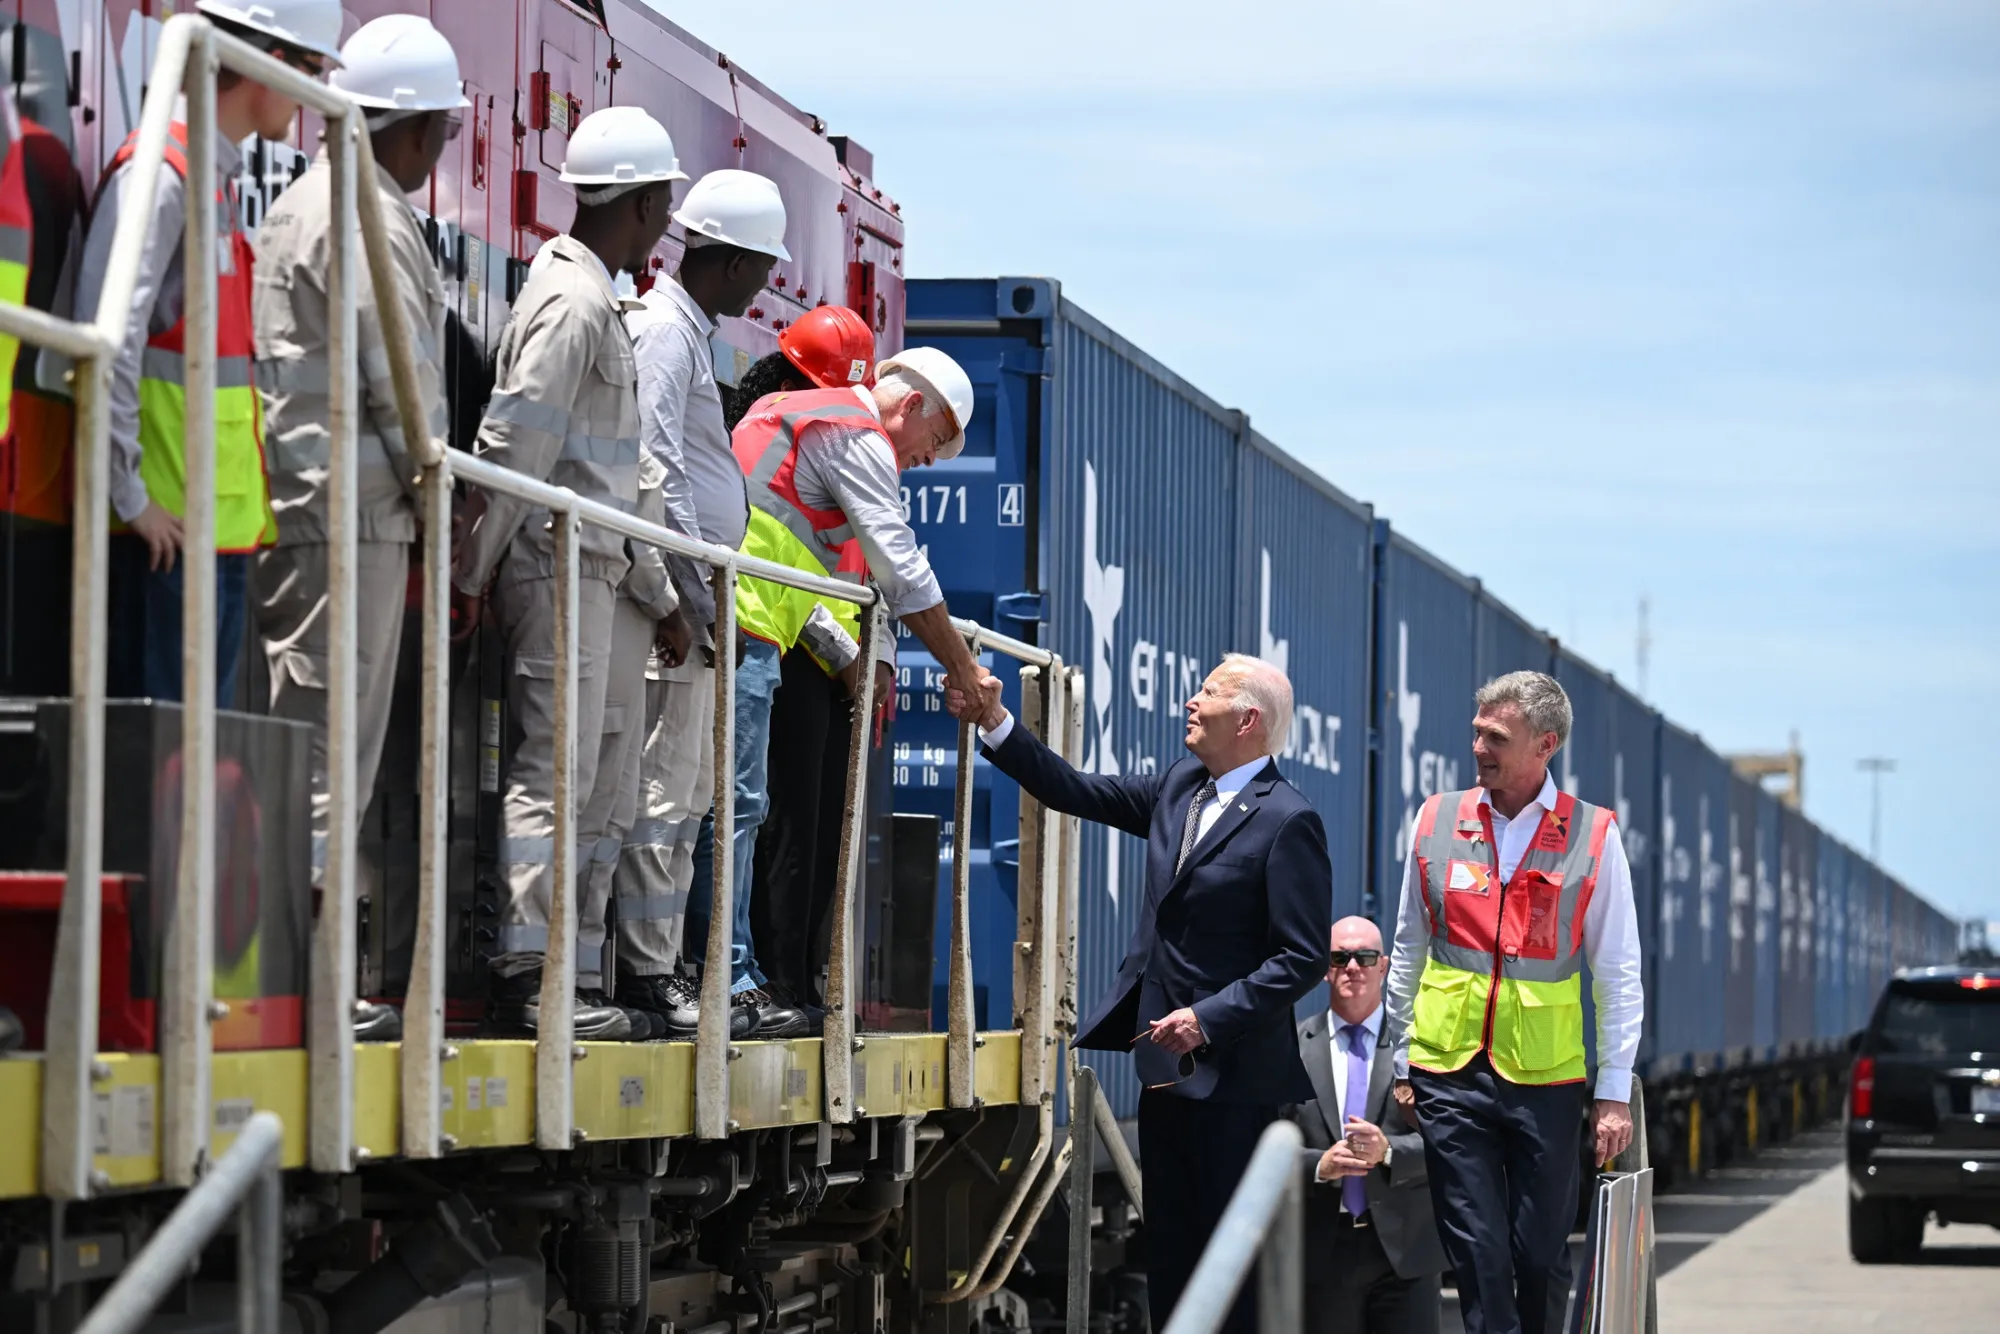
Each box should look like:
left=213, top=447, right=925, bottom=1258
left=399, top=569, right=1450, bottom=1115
left=252, top=14, right=470, bottom=1040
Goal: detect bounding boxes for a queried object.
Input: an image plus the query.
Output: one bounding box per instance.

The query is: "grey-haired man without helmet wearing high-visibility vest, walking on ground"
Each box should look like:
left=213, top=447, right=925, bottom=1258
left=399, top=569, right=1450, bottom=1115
left=1388, top=672, right=1644, bottom=1334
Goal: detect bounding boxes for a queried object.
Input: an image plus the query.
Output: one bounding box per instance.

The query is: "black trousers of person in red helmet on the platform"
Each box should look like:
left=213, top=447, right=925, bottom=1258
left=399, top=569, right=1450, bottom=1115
left=750, top=648, right=854, bottom=1002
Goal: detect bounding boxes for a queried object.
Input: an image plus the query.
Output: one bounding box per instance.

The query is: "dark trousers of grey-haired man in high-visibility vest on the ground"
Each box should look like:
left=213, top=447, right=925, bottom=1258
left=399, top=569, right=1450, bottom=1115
left=1410, top=1052, right=1586, bottom=1334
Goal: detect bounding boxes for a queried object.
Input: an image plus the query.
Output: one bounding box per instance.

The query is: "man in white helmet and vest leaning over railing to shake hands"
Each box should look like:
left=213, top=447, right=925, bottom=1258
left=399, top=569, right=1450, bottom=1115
left=688, top=348, right=996, bottom=1012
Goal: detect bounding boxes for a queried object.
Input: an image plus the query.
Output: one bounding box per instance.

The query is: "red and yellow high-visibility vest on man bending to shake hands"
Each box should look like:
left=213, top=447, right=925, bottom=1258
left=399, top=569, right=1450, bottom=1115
left=730, top=390, right=882, bottom=652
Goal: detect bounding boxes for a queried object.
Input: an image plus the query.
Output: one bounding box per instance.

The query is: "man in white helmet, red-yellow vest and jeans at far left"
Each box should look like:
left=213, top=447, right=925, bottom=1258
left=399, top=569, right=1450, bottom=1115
left=76, top=0, right=340, bottom=706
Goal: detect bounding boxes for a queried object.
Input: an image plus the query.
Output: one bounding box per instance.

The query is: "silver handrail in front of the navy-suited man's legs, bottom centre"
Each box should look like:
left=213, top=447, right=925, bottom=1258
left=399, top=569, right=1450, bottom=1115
left=1164, top=1120, right=1306, bottom=1334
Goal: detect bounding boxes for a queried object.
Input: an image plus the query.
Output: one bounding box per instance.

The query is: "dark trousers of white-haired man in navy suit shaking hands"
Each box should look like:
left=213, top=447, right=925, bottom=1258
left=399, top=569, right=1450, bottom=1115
left=1138, top=1090, right=1278, bottom=1334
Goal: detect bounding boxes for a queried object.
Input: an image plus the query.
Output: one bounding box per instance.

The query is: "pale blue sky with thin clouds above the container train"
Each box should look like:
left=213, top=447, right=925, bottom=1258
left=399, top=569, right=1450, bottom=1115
left=664, top=0, right=2000, bottom=918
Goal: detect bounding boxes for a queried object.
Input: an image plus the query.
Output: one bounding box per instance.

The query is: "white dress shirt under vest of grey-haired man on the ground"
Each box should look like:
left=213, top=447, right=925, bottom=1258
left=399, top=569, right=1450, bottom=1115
left=1388, top=776, right=1646, bottom=1102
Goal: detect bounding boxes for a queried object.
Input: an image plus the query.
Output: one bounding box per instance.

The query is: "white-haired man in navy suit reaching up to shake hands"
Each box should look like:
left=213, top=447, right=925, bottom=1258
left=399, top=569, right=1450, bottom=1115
left=946, top=654, right=1334, bottom=1332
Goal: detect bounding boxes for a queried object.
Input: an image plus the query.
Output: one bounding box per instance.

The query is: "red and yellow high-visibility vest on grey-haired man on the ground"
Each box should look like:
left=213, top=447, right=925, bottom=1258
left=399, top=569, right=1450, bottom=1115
left=1410, top=788, right=1612, bottom=1084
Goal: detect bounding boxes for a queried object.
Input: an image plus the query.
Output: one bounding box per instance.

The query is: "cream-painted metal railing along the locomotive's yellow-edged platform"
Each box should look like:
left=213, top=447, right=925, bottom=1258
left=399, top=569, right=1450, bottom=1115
left=19, top=14, right=1082, bottom=1200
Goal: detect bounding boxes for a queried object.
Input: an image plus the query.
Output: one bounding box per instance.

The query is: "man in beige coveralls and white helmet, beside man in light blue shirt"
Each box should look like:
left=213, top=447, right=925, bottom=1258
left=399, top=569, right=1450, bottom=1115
left=452, top=106, right=686, bottom=1040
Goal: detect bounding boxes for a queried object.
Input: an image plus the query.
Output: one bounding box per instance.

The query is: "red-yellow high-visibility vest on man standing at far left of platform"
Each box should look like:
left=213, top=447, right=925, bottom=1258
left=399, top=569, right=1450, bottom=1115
left=100, top=120, right=278, bottom=552
